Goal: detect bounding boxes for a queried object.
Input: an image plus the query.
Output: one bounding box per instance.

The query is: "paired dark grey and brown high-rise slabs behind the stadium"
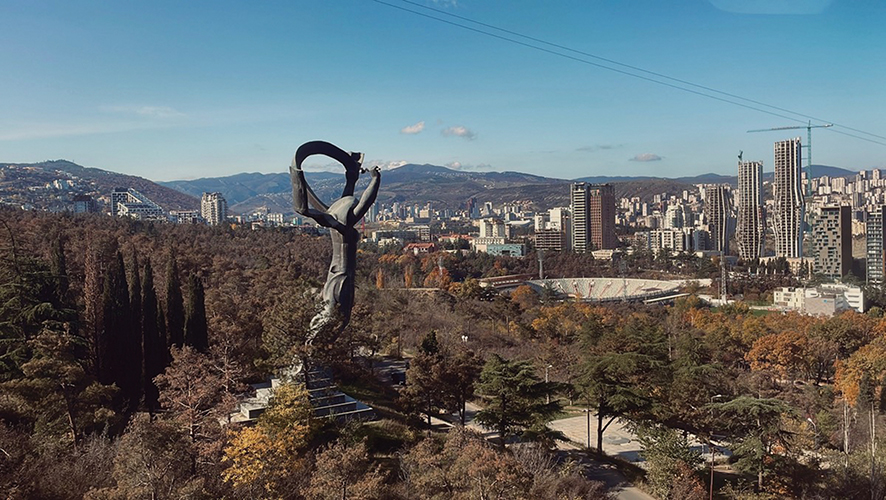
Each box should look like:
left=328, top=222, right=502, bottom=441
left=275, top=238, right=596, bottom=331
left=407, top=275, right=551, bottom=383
left=570, top=182, right=618, bottom=253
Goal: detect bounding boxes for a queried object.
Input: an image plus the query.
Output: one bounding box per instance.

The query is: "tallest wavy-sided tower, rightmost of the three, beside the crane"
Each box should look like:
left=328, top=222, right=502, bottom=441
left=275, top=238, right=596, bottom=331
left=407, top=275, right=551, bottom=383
left=773, top=137, right=804, bottom=258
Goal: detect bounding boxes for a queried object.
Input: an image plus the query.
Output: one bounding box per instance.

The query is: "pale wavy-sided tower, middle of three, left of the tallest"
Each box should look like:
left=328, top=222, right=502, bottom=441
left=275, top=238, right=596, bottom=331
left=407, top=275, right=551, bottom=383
left=738, top=161, right=765, bottom=260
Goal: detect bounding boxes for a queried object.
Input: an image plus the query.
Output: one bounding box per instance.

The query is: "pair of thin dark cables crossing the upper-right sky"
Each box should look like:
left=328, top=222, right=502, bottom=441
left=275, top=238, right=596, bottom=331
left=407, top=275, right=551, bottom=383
left=373, top=0, right=886, bottom=146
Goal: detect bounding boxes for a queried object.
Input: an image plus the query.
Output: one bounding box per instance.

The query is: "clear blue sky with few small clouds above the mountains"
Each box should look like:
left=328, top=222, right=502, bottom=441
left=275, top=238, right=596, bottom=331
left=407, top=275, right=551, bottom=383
left=0, top=0, right=886, bottom=181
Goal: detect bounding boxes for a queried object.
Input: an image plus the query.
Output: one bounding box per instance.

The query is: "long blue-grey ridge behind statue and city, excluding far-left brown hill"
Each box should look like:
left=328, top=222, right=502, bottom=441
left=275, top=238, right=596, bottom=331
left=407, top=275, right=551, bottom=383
left=162, top=164, right=855, bottom=213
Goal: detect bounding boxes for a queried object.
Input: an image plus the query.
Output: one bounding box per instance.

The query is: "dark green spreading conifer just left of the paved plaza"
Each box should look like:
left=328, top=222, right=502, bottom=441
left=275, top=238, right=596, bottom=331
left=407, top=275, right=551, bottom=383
left=476, top=354, right=561, bottom=445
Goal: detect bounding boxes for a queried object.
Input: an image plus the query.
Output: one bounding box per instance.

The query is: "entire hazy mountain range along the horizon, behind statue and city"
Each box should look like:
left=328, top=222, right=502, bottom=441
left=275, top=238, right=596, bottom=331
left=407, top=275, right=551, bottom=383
left=0, top=160, right=856, bottom=214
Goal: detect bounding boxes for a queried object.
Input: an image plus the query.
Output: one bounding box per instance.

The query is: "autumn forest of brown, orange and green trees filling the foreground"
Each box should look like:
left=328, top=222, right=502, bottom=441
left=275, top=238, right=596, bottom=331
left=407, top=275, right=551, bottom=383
left=0, top=208, right=886, bottom=499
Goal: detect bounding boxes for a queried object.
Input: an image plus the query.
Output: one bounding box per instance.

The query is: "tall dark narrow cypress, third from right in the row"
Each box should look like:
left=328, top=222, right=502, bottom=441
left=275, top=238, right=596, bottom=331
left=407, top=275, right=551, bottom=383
left=141, top=260, right=166, bottom=415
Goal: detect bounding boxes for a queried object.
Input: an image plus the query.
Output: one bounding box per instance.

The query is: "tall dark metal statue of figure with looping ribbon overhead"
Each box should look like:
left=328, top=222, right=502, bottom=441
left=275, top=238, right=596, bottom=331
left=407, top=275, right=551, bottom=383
left=289, top=141, right=381, bottom=345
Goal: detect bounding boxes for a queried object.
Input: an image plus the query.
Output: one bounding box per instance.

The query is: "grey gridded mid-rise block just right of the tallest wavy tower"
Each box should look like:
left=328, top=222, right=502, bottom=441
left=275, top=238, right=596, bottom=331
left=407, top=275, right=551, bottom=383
left=812, top=205, right=852, bottom=279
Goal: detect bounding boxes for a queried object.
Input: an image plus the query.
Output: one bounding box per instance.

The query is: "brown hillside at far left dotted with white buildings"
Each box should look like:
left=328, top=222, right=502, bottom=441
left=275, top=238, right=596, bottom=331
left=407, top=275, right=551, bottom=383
left=0, top=160, right=200, bottom=210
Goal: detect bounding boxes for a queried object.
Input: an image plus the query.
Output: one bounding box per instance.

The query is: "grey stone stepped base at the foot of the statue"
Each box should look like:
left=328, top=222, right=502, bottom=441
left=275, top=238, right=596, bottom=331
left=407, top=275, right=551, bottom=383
left=228, top=368, right=376, bottom=423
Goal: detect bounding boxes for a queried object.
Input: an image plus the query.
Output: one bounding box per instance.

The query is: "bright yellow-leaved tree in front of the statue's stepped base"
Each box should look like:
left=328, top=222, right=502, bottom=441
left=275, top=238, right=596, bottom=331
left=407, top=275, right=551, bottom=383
left=222, top=384, right=314, bottom=497
